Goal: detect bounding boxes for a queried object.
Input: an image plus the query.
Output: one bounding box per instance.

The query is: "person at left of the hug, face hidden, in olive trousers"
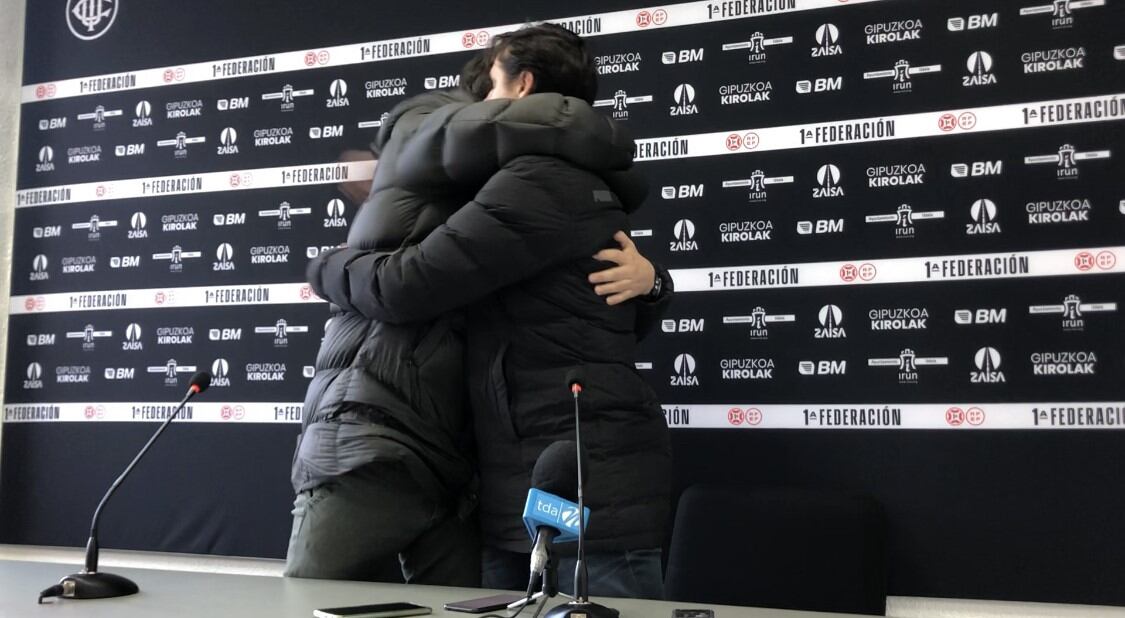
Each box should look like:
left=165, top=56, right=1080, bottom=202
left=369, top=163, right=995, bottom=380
left=286, top=50, right=666, bottom=586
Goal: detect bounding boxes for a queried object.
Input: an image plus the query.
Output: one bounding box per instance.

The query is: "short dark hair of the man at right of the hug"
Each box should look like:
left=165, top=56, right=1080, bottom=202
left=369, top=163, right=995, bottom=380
left=492, top=24, right=597, bottom=105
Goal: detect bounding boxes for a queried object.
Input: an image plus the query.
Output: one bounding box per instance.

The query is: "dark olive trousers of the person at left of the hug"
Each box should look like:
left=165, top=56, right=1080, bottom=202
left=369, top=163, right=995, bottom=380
left=286, top=462, right=480, bottom=586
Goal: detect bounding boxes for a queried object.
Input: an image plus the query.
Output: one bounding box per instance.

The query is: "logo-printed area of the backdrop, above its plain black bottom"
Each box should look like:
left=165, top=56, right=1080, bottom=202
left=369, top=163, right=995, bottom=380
left=5, top=0, right=1125, bottom=431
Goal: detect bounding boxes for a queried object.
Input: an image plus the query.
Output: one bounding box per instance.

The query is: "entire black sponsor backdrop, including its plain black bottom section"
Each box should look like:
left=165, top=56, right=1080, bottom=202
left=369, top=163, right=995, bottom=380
left=0, top=0, right=1125, bottom=604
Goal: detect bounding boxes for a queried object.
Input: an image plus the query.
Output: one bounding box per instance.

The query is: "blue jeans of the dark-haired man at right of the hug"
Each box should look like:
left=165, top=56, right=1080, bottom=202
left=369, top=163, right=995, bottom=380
left=480, top=547, right=664, bottom=600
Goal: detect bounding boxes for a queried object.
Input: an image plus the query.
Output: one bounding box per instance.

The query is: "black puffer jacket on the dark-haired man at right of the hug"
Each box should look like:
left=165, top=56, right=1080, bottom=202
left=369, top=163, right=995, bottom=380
left=317, top=93, right=672, bottom=552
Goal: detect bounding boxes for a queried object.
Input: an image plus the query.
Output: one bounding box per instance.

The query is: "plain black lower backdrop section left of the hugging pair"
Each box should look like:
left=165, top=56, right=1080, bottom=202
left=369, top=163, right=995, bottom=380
left=0, top=423, right=298, bottom=557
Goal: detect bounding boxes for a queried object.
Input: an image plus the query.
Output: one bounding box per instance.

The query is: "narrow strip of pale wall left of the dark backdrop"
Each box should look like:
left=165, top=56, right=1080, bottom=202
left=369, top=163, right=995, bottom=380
left=0, top=0, right=25, bottom=463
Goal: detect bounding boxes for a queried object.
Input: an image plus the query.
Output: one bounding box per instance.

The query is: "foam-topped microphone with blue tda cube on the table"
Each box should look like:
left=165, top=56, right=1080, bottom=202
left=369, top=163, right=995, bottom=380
left=523, top=440, right=590, bottom=577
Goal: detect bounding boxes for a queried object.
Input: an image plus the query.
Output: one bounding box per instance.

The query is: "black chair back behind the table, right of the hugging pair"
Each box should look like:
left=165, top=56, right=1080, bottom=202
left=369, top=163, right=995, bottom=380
left=665, top=485, right=887, bottom=616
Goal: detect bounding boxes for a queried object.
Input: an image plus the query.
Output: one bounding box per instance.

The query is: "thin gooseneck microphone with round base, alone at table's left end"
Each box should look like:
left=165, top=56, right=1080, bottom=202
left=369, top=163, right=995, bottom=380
left=38, top=371, right=212, bottom=603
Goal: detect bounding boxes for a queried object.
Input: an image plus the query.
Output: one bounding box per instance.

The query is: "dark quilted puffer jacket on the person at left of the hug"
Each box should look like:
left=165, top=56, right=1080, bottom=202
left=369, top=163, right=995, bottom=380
left=291, top=92, right=474, bottom=499
